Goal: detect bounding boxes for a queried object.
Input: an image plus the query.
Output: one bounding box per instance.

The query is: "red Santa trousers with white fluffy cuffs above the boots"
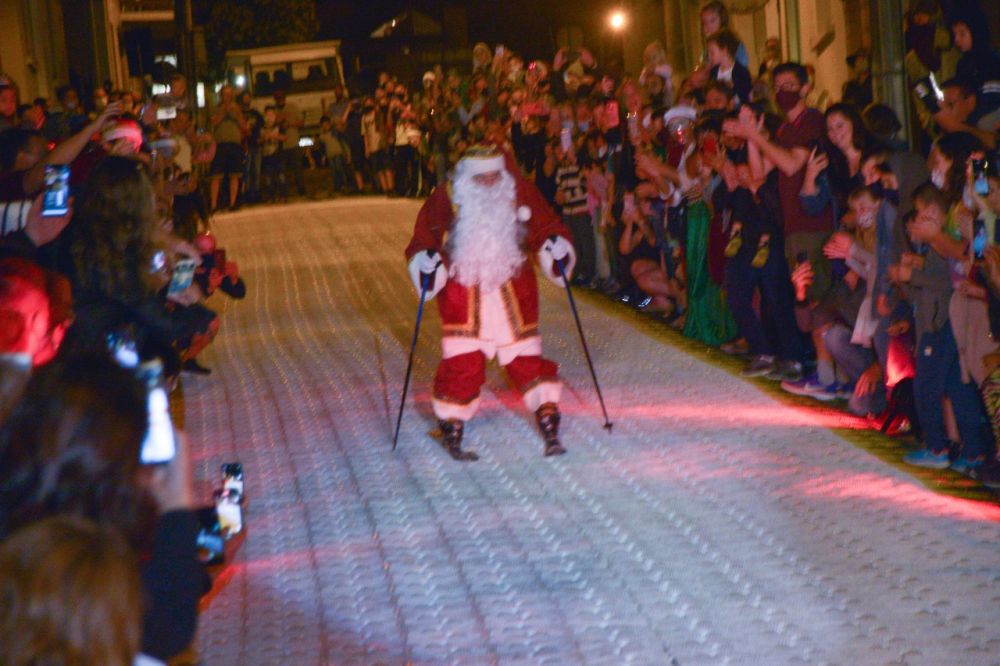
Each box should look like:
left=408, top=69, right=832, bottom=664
left=434, top=351, right=562, bottom=421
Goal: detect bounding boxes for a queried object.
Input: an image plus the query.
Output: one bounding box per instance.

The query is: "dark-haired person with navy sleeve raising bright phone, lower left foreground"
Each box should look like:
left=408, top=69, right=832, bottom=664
left=0, top=351, right=206, bottom=660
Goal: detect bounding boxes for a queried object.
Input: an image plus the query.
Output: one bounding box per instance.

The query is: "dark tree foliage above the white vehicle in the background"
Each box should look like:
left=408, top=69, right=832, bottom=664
left=195, top=0, right=319, bottom=79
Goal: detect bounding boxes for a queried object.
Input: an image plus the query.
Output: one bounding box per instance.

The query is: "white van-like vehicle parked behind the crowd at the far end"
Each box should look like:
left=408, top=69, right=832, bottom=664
left=226, top=40, right=344, bottom=141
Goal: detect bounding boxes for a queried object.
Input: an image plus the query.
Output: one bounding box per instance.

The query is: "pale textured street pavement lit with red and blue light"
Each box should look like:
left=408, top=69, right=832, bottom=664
left=184, top=199, right=1000, bottom=666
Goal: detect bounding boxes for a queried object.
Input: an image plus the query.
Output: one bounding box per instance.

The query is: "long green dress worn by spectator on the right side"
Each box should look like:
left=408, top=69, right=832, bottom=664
left=684, top=201, right=737, bottom=347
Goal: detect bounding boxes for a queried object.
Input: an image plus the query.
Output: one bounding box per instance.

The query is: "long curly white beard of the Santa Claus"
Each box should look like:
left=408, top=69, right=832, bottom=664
left=448, top=171, right=525, bottom=292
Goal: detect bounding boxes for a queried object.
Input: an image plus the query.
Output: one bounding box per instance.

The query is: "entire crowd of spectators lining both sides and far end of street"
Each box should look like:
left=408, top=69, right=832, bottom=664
left=0, top=2, right=1000, bottom=664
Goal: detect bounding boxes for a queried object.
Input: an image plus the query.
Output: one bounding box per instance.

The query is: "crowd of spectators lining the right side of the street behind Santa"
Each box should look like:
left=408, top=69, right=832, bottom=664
left=306, top=2, right=1000, bottom=487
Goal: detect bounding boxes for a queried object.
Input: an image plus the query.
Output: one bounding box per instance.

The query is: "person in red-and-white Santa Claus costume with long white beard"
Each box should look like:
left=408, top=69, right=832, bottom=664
left=406, top=146, right=576, bottom=460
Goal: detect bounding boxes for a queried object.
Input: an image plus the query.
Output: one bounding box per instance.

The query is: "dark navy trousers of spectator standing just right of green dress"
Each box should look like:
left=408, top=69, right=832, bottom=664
left=725, top=247, right=804, bottom=362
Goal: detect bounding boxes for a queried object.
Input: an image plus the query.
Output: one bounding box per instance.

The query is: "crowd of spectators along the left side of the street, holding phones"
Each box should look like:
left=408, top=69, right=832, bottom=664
left=0, top=48, right=245, bottom=666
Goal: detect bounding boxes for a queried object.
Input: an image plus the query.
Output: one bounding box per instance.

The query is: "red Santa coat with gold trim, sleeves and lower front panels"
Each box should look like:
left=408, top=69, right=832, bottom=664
left=406, top=169, right=572, bottom=340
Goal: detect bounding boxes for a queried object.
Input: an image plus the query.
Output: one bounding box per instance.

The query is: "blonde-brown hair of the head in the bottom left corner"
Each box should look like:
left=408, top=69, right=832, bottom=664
left=0, top=516, right=142, bottom=666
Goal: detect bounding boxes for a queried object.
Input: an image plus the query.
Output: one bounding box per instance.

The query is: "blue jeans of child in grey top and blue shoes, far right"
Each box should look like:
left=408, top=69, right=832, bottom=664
left=913, top=322, right=987, bottom=458
